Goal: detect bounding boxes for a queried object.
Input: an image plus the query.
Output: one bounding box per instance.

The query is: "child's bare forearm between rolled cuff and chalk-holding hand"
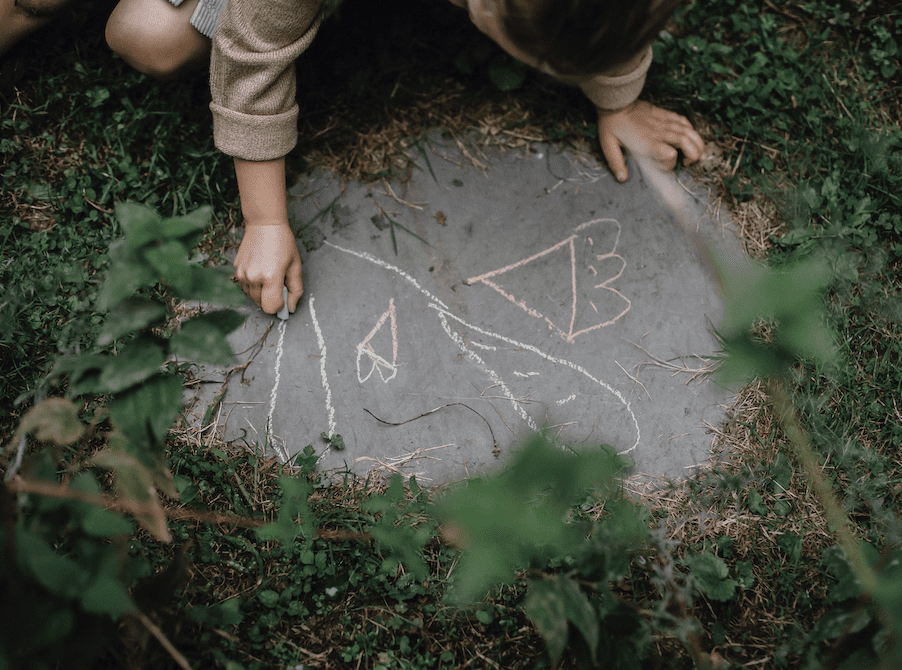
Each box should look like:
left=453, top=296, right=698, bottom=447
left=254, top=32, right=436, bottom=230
left=235, top=157, right=288, bottom=227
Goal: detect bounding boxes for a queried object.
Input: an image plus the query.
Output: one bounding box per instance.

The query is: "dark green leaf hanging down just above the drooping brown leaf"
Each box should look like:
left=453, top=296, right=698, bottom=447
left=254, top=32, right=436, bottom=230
left=110, top=374, right=184, bottom=445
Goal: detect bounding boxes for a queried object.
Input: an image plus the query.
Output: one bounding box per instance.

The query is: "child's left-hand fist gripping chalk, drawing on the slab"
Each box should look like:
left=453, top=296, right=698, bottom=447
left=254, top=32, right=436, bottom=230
left=235, top=222, right=304, bottom=314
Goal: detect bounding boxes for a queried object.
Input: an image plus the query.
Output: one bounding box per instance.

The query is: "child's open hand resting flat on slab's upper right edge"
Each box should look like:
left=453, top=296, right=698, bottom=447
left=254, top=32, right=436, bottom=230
left=598, top=100, right=705, bottom=182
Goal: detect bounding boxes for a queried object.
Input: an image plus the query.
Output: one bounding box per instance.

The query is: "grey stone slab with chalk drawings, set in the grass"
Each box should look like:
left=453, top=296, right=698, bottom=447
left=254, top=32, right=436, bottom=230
left=187, top=132, right=739, bottom=483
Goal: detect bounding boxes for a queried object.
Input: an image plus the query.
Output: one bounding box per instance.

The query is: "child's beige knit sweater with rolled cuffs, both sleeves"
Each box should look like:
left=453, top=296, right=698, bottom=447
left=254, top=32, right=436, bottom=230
left=210, top=0, right=651, bottom=161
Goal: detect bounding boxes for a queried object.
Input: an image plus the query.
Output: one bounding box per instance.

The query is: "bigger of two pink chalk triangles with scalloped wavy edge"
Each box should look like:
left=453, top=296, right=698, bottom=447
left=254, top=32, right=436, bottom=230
left=465, top=219, right=632, bottom=343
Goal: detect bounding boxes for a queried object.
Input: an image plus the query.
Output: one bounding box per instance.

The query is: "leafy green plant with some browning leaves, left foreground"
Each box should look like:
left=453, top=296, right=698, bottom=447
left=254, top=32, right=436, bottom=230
left=0, top=204, right=243, bottom=667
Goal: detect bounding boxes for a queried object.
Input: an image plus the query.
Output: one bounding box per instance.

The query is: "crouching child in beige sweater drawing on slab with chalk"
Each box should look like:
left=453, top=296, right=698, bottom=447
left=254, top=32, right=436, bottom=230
left=0, top=0, right=704, bottom=314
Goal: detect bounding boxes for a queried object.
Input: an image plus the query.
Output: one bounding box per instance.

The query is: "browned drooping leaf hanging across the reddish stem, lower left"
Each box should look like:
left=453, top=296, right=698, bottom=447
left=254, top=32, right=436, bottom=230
left=91, top=432, right=172, bottom=542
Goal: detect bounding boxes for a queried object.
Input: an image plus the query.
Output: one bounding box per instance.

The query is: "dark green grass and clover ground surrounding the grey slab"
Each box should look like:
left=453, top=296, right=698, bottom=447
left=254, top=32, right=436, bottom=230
left=0, top=0, right=902, bottom=668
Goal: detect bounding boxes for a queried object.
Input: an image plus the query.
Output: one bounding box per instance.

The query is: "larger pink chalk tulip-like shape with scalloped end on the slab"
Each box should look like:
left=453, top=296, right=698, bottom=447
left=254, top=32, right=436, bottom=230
left=466, top=218, right=633, bottom=343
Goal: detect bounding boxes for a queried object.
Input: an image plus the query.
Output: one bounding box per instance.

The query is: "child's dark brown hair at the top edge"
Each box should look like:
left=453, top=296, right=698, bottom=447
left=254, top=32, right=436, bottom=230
left=499, top=0, right=681, bottom=75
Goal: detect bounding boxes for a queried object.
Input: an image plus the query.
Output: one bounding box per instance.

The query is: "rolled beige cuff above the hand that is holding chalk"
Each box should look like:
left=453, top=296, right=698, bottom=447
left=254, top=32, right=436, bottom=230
left=210, top=102, right=298, bottom=161
